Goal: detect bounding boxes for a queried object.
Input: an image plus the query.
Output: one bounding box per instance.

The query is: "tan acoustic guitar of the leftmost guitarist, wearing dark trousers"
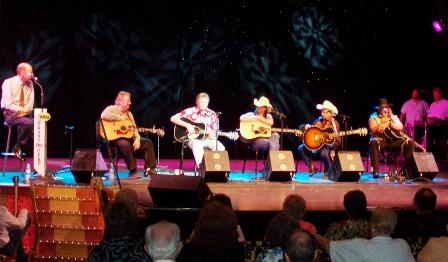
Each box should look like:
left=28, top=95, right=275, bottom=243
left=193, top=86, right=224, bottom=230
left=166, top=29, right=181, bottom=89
left=99, top=120, right=165, bottom=141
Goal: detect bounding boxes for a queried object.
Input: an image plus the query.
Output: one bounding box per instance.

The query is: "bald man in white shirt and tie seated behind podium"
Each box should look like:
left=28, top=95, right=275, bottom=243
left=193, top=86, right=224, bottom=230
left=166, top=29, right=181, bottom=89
left=1, top=62, right=34, bottom=161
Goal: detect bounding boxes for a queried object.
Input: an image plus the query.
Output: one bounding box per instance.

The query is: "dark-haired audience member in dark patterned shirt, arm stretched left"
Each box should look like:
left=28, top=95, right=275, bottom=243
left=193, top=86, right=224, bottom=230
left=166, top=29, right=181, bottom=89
left=325, top=190, right=370, bottom=240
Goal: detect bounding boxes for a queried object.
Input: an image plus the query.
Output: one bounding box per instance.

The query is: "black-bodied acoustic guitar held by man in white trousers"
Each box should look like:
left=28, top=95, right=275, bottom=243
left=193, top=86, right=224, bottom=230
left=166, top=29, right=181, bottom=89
left=174, top=117, right=239, bottom=142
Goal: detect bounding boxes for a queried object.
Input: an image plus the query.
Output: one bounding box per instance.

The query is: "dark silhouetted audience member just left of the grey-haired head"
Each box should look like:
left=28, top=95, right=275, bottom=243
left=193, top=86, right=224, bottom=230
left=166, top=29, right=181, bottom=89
left=87, top=202, right=150, bottom=262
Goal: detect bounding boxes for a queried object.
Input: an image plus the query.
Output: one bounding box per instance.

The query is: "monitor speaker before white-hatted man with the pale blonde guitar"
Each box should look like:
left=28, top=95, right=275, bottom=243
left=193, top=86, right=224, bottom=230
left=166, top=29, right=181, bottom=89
left=266, top=151, right=295, bottom=182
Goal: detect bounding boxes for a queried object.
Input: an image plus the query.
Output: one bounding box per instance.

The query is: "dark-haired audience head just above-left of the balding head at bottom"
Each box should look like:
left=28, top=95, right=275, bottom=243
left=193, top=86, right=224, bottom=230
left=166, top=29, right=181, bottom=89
left=265, top=212, right=299, bottom=247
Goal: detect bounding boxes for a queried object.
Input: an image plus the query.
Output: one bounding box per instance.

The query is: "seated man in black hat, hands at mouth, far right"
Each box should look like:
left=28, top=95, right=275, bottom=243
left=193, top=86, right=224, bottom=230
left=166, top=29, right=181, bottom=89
left=369, top=98, right=415, bottom=178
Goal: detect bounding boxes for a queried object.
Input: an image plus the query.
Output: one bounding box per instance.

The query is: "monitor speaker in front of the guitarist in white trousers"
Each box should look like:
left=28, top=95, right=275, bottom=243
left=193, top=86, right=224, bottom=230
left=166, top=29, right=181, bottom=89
left=204, top=150, right=230, bottom=183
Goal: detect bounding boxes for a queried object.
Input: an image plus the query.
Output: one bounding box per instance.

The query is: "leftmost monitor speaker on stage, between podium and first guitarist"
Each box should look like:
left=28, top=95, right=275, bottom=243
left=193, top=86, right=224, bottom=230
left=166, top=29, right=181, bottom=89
left=71, top=148, right=108, bottom=184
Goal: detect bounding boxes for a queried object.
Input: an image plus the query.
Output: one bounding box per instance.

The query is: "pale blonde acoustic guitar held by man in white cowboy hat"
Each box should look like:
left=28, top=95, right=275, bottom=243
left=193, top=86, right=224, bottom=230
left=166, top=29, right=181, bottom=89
left=240, top=121, right=303, bottom=142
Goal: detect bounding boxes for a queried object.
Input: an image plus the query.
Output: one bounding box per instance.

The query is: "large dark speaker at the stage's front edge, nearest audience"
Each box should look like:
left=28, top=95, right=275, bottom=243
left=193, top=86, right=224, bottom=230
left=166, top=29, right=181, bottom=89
left=148, top=175, right=211, bottom=208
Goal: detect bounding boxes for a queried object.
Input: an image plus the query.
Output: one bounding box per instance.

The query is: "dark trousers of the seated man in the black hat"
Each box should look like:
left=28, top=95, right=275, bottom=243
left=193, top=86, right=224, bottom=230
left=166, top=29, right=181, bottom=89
left=369, top=139, right=415, bottom=172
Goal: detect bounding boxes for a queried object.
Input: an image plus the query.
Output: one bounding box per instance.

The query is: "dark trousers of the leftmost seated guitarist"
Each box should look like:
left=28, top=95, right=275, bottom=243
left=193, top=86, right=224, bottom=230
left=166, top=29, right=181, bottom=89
left=110, top=138, right=156, bottom=173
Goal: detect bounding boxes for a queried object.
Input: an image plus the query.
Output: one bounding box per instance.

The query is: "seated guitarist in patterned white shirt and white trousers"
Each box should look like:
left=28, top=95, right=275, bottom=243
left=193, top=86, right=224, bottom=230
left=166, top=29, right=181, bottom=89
left=170, top=93, right=225, bottom=168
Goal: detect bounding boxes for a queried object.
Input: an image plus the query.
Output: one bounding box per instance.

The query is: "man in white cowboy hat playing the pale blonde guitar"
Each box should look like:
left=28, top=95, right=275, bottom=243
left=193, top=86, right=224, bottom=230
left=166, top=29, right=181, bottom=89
left=240, top=96, right=280, bottom=151
